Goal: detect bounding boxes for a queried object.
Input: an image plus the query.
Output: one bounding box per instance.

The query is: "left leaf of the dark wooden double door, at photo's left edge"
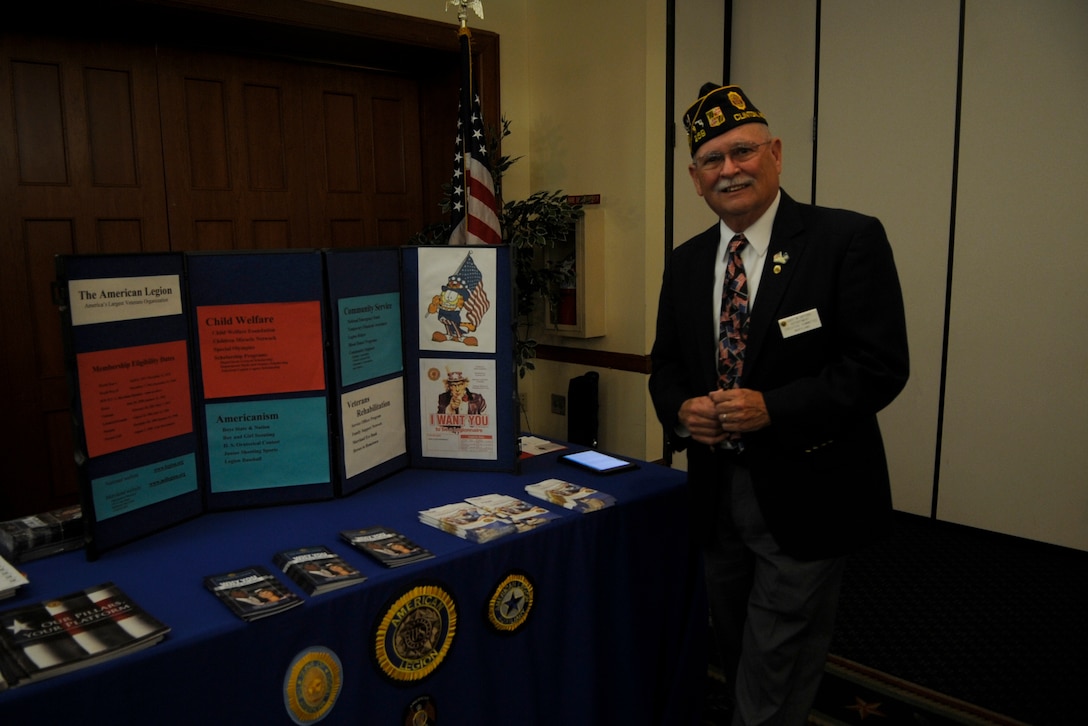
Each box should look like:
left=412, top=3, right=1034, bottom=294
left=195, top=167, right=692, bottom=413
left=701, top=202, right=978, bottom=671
left=0, top=35, right=169, bottom=518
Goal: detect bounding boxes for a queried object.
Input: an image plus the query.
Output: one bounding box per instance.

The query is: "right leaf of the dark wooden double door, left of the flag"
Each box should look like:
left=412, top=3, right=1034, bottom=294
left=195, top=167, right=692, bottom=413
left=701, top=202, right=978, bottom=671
left=159, top=51, right=423, bottom=249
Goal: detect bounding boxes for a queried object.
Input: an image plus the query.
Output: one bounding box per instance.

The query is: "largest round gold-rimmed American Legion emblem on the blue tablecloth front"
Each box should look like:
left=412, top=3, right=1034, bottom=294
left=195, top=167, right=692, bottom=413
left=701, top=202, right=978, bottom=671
left=374, top=585, right=457, bottom=682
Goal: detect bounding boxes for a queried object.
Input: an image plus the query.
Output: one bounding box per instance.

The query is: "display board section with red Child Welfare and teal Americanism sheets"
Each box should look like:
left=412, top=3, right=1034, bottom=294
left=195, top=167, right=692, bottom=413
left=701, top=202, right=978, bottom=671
left=186, top=250, right=333, bottom=509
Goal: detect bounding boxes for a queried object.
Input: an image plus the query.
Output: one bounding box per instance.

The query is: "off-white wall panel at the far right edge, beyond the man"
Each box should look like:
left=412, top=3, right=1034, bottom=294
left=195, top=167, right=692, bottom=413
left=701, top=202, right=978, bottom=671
left=938, top=0, right=1088, bottom=550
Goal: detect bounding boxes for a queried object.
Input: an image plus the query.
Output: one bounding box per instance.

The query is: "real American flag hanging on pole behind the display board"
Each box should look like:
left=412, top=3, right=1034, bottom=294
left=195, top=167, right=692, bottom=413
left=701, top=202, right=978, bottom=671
left=449, top=28, right=503, bottom=245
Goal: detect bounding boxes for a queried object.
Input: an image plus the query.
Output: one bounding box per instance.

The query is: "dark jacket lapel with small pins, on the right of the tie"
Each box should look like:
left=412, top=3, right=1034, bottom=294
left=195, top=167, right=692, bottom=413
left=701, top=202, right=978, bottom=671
left=744, top=192, right=806, bottom=372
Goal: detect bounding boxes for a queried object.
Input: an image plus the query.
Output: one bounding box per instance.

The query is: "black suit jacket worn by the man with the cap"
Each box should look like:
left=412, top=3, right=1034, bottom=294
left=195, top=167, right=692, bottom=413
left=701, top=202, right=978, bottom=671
left=650, top=192, right=908, bottom=559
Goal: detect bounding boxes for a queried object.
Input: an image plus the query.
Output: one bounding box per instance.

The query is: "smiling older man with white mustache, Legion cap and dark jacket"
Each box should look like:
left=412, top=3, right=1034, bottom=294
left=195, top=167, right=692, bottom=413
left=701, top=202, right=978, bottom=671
left=650, top=84, right=908, bottom=726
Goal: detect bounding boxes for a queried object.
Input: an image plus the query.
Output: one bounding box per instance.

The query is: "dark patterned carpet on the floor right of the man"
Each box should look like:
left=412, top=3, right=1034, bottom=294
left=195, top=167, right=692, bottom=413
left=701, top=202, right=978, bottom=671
left=704, top=514, right=1088, bottom=726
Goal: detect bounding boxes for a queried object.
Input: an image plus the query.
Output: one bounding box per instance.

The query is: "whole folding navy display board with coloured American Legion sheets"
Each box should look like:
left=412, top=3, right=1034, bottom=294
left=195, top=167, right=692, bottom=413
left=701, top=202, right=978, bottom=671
left=57, top=247, right=518, bottom=558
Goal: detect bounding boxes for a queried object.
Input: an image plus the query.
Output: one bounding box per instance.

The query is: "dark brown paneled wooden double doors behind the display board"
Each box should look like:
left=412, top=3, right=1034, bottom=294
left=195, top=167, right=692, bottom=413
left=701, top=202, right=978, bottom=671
left=0, top=9, right=467, bottom=519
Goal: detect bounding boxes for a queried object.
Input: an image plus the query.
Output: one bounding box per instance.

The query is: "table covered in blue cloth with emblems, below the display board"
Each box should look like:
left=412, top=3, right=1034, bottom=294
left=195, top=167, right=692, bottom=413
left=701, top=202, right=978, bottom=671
left=0, top=453, right=706, bottom=726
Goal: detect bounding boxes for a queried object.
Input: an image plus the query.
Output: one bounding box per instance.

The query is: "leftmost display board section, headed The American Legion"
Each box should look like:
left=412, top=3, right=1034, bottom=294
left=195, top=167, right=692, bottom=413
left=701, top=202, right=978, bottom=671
left=58, top=254, right=203, bottom=556
